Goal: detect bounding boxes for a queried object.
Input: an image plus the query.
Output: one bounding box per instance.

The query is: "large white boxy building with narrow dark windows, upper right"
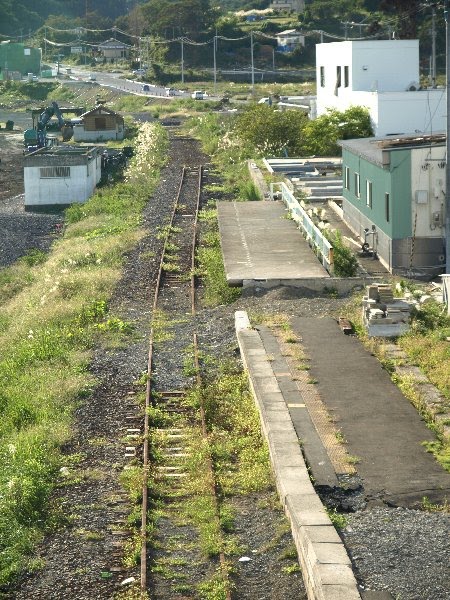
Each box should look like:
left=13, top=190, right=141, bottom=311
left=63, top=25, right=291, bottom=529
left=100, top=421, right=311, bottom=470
left=316, top=40, right=446, bottom=136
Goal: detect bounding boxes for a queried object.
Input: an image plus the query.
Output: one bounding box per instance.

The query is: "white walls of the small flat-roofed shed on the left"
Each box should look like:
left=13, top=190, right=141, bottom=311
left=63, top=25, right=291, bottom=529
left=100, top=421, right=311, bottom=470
left=24, top=160, right=100, bottom=206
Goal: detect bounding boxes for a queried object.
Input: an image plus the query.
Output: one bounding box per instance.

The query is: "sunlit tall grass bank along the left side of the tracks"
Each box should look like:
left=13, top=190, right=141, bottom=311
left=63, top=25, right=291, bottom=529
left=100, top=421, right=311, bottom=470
left=0, top=124, right=166, bottom=586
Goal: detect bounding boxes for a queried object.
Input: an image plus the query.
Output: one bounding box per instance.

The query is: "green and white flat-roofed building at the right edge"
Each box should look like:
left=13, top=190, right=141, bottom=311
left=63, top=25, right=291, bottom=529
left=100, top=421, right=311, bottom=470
left=341, top=134, right=446, bottom=276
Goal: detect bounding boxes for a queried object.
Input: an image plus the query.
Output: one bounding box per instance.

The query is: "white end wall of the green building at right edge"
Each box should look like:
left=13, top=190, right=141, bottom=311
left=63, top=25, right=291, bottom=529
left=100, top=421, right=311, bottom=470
left=411, top=146, right=445, bottom=237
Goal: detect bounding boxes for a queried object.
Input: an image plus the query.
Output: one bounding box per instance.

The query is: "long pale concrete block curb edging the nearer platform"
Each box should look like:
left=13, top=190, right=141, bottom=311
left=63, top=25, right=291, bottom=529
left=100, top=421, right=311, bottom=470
left=235, top=311, right=361, bottom=600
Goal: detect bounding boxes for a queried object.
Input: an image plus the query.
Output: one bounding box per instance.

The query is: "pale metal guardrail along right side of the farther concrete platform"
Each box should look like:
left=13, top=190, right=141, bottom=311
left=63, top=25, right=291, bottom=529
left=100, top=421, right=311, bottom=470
left=270, top=181, right=334, bottom=275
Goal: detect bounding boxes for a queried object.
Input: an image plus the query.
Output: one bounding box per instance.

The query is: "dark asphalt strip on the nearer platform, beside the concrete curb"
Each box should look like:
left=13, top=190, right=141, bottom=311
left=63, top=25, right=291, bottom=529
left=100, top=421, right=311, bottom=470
left=292, top=317, right=450, bottom=508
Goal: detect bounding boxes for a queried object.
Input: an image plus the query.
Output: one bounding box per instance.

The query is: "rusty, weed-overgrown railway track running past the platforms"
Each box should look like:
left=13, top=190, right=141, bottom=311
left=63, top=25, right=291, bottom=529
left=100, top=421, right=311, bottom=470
left=140, top=166, right=231, bottom=599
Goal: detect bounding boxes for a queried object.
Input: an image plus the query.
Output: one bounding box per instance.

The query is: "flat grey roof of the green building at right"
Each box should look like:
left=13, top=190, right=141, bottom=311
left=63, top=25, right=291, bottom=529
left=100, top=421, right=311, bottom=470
left=339, top=133, right=446, bottom=166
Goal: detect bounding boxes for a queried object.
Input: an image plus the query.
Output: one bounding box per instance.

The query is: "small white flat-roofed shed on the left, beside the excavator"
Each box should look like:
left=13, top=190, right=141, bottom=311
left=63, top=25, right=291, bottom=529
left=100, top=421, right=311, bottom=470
left=24, top=146, right=101, bottom=208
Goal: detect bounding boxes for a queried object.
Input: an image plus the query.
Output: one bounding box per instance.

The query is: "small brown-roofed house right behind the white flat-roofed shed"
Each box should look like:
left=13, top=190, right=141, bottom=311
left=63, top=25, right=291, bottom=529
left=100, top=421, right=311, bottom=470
left=73, top=104, right=125, bottom=142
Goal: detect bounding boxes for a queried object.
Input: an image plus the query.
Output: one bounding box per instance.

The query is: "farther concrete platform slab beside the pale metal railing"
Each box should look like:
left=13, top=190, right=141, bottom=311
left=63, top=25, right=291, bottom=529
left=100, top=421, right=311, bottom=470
left=217, top=202, right=329, bottom=285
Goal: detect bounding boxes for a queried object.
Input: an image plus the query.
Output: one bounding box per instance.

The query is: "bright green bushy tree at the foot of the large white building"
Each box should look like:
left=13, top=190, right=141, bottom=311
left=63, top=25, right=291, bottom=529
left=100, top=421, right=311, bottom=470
left=302, top=106, right=373, bottom=156
